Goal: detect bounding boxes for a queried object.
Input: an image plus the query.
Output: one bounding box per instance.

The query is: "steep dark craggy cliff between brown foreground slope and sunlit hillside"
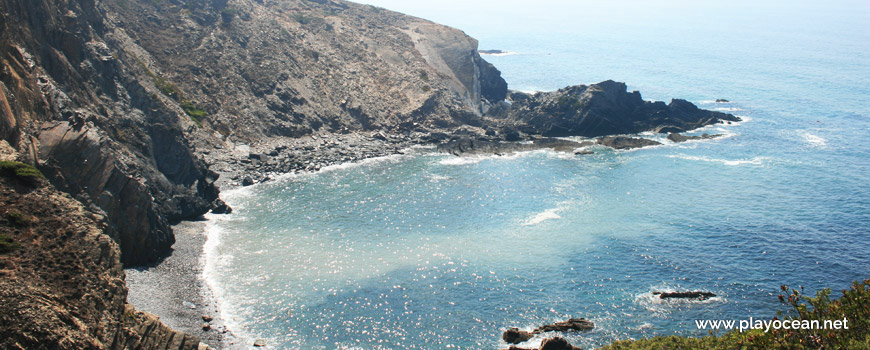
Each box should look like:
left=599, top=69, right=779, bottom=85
left=0, top=0, right=225, bottom=264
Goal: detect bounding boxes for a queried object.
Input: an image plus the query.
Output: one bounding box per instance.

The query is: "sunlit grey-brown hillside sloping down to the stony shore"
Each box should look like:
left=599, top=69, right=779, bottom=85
left=104, top=0, right=507, bottom=141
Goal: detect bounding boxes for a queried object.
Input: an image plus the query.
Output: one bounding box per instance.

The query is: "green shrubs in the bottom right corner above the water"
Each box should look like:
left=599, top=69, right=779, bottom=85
left=602, top=279, right=870, bottom=350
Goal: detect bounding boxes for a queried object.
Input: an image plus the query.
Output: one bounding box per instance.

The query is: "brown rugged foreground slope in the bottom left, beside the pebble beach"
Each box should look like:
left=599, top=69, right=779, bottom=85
left=0, top=141, right=200, bottom=349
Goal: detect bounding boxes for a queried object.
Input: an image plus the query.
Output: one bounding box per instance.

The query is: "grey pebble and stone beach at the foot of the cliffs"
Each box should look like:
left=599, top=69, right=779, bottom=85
left=125, top=119, right=744, bottom=350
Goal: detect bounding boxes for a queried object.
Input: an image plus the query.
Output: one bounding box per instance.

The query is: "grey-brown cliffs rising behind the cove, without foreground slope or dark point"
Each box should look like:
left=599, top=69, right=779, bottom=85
left=0, top=0, right=507, bottom=265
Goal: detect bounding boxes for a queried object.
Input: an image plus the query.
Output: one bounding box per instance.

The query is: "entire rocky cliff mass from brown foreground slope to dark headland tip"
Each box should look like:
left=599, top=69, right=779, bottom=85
left=0, top=0, right=736, bottom=349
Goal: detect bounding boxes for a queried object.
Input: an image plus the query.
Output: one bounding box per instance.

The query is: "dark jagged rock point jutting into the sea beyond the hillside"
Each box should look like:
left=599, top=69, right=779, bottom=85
left=493, top=80, right=740, bottom=137
